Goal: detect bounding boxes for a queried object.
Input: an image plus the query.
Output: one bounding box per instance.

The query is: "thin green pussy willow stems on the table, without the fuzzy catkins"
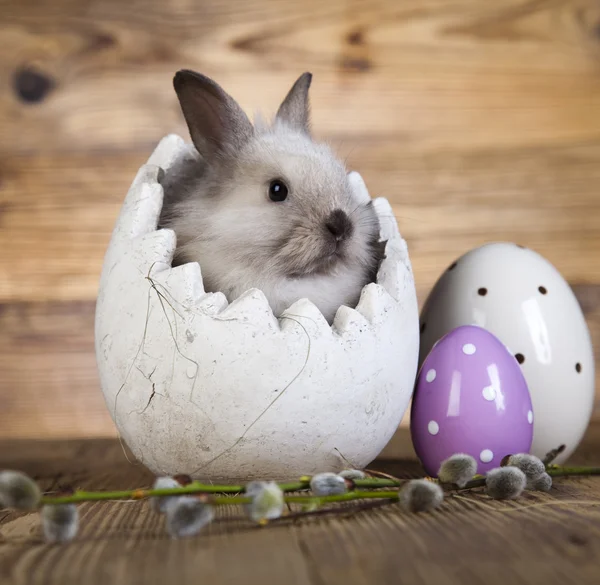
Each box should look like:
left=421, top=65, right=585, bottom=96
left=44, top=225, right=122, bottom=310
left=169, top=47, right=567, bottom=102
left=40, top=466, right=600, bottom=505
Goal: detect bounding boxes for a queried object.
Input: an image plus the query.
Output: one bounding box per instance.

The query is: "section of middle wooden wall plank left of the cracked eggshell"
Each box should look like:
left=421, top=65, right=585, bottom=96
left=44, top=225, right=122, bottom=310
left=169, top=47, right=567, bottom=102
left=0, top=153, right=139, bottom=302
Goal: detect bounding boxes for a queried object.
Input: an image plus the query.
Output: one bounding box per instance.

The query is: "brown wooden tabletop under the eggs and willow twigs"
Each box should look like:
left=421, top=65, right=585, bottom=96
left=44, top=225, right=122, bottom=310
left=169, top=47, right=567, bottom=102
left=0, top=423, right=600, bottom=585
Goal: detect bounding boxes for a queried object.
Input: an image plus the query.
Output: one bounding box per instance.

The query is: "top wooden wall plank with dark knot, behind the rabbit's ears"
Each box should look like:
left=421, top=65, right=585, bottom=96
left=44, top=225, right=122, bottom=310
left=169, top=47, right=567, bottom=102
left=0, top=0, right=600, bottom=154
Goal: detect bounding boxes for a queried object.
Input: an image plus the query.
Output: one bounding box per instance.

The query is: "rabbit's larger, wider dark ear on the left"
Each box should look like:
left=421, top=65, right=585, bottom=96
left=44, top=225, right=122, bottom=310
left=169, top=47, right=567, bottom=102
left=173, top=69, right=254, bottom=161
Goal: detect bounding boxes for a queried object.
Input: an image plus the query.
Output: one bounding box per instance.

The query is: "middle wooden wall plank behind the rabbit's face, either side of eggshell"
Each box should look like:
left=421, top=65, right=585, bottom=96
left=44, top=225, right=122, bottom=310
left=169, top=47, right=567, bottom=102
left=0, top=140, right=600, bottom=302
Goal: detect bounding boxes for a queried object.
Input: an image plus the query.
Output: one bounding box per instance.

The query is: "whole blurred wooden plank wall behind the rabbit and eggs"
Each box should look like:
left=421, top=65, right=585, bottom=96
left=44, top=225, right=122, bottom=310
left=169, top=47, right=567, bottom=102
left=0, top=0, right=600, bottom=437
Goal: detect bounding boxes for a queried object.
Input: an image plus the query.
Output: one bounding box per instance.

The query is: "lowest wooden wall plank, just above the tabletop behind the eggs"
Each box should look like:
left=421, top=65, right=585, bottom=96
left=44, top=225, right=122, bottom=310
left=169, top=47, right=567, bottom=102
left=0, top=285, right=600, bottom=438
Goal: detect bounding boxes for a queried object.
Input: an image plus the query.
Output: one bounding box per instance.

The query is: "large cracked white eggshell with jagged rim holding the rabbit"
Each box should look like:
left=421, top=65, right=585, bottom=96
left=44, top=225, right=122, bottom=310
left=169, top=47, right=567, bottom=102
left=95, top=135, right=419, bottom=481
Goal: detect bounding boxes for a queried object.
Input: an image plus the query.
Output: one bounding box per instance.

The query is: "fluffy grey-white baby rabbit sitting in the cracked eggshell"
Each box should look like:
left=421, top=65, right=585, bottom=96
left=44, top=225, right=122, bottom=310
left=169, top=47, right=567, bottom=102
left=160, top=70, right=383, bottom=323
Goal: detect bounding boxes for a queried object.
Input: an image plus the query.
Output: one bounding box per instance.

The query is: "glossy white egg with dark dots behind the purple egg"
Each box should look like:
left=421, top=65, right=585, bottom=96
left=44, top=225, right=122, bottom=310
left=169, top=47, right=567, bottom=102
left=419, top=243, right=594, bottom=463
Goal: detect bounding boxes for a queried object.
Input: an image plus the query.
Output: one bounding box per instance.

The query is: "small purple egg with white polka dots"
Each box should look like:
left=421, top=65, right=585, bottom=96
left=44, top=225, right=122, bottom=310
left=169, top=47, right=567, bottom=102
left=410, top=325, right=533, bottom=477
